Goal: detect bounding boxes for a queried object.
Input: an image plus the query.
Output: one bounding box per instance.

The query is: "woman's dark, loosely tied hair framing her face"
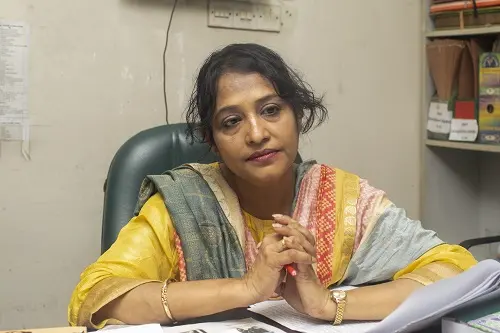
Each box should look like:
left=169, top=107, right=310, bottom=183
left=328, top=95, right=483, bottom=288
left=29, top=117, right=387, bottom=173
left=186, top=44, right=328, bottom=143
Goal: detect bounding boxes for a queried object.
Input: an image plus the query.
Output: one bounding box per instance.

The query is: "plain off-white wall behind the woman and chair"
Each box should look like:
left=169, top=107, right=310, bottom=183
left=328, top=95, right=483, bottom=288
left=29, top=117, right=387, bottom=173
left=0, top=0, right=421, bottom=329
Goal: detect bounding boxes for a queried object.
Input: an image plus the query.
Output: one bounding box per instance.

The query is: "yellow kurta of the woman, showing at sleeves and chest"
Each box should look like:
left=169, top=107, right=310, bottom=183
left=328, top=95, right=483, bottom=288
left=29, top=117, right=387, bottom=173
left=68, top=194, right=476, bottom=328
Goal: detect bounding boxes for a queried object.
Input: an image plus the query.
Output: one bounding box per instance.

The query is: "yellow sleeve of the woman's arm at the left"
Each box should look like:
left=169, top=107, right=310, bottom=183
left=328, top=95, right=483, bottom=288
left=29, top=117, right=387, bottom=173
left=68, top=195, right=178, bottom=328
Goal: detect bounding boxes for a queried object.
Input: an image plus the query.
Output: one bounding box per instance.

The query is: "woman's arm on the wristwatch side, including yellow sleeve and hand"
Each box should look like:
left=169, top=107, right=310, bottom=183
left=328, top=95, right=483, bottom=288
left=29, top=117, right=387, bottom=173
left=275, top=217, right=477, bottom=321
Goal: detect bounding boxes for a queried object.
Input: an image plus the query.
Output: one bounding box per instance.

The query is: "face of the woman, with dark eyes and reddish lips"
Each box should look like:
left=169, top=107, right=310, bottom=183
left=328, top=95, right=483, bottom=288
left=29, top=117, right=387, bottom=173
left=212, top=73, right=299, bottom=186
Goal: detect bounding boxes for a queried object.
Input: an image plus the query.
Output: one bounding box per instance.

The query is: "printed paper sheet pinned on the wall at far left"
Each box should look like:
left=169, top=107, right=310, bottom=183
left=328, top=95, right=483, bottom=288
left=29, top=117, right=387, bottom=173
left=0, top=20, right=30, bottom=160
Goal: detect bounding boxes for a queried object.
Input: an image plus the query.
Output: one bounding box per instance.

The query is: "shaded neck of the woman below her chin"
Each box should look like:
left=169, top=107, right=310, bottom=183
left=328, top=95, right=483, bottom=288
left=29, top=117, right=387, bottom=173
left=221, top=165, right=295, bottom=220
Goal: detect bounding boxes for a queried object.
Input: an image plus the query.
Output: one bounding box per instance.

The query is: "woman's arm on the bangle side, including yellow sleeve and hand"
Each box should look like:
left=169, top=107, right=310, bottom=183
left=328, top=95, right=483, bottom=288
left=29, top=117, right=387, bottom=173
left=69, top=196, right=313, bottom=328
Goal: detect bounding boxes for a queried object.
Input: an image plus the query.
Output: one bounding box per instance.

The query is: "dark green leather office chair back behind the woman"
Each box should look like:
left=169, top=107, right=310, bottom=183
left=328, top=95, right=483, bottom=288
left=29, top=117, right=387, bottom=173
left=101, top=124, right=302, bottom=253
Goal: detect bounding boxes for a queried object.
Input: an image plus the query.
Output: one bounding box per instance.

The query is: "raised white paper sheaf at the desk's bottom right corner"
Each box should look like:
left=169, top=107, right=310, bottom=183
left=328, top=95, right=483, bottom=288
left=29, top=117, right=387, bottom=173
left=368, top=260, right=500, bottom=333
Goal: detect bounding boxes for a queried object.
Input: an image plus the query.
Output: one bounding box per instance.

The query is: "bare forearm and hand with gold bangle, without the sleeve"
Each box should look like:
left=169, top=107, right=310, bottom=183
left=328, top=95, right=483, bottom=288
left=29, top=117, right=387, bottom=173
left=95, top=235, right=313, bottom=324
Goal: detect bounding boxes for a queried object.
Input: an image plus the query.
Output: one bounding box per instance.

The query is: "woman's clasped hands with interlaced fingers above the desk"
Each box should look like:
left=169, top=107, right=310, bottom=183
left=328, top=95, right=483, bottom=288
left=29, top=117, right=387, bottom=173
left=245, top=215, right=330, bottom=318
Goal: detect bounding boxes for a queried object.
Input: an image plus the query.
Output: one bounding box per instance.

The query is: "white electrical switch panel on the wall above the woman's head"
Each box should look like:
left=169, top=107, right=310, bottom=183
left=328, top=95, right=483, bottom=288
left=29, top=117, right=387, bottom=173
left=208, top=0, right=281, bottom=32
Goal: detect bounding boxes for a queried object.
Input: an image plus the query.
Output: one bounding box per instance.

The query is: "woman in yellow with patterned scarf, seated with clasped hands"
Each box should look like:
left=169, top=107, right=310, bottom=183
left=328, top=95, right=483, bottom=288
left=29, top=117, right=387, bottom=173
left=68, top=44, right=476, bottom=328
